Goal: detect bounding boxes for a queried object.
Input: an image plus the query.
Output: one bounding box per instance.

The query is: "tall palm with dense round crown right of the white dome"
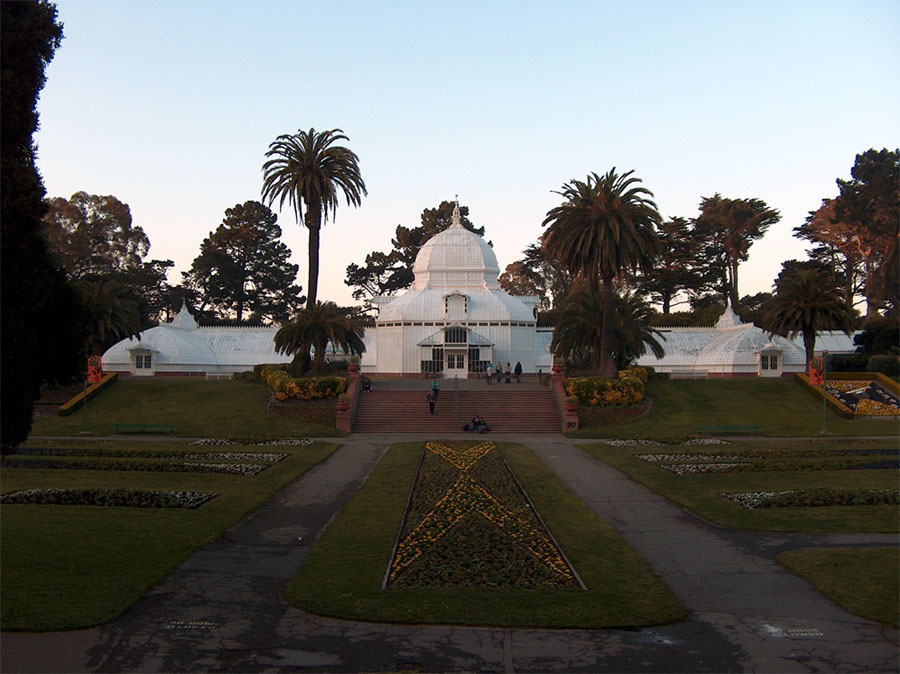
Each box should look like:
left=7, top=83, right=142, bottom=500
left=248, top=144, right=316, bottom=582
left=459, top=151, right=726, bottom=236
left=543, top=168, right=661, bottom=377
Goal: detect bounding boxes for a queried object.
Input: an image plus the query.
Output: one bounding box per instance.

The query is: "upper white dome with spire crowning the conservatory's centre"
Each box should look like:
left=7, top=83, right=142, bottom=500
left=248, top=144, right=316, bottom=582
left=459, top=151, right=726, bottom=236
left=412, top=197, right=500, bottom=290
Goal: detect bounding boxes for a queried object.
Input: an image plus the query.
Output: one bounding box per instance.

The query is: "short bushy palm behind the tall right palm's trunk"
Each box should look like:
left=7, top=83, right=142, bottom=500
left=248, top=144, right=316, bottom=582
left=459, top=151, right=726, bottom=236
left=551, top=290, right=665, bottom=369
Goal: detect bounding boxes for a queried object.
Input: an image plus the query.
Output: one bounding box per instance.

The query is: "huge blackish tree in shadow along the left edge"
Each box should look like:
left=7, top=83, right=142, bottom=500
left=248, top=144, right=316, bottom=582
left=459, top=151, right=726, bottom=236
left=0, top=0, right=86, bottom=448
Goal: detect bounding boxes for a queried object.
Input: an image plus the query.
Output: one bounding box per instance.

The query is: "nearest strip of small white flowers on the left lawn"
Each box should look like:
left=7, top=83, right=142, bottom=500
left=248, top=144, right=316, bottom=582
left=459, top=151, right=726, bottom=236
left=0, top=489, right=218, bottom=509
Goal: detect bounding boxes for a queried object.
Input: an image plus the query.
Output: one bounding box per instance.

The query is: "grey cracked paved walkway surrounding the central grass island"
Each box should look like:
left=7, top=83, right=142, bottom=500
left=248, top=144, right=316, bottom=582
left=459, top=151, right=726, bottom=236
left=0, top=435, right=898, bottom=672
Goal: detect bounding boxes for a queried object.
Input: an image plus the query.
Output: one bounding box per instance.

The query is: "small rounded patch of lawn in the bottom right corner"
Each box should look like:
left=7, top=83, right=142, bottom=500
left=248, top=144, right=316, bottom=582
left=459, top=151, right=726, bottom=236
left=778, top=548, right=900, bottom=628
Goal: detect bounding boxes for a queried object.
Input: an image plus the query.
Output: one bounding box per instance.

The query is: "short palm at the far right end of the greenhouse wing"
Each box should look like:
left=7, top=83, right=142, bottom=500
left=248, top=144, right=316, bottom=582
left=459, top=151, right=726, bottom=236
left=766, top=268, right=854, bottom=369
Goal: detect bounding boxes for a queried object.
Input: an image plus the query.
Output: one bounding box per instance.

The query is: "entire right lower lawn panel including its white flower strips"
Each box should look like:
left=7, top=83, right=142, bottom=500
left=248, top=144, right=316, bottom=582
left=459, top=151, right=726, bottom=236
left=584, top=437, right=900, bottom=533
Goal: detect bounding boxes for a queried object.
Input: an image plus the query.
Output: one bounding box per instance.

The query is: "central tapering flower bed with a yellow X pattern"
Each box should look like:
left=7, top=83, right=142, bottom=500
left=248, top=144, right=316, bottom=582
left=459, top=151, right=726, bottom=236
left=387, top=442, right=580, bottom=588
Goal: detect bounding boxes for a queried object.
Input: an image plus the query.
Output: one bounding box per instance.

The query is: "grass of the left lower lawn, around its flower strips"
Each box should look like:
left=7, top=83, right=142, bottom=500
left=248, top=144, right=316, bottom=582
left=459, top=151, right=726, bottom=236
left=0, top=441, right=337, bottom=631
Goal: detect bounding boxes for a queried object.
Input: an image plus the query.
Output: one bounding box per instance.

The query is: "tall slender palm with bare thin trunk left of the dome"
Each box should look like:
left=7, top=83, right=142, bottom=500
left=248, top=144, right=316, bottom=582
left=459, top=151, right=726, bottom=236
left=262, top=129, right=367, bottom=308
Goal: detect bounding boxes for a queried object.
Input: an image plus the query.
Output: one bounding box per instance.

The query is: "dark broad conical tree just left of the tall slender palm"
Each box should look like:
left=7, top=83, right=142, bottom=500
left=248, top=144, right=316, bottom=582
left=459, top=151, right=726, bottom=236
left=182, top=201, right=303, bottom=323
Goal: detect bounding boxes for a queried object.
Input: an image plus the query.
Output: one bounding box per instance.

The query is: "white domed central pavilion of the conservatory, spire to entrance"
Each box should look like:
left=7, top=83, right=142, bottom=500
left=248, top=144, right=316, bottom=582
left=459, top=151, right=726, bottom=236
left=361, top=204, right=549, bottom=378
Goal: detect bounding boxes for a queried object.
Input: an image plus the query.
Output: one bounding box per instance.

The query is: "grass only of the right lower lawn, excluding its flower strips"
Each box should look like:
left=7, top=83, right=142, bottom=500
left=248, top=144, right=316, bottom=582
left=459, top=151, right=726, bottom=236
left=582, top=439, right=898, bottom=533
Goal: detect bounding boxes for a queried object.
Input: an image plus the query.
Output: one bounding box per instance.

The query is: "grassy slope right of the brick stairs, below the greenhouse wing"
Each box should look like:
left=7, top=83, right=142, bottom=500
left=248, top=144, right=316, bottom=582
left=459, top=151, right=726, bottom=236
left=570, top=377, right=900, bottom=438
